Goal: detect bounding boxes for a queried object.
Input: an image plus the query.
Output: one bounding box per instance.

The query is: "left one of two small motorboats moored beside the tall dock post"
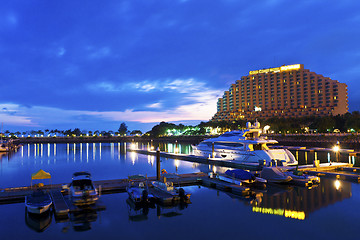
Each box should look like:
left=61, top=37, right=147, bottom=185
left=126, top=175, right=154, bottom=203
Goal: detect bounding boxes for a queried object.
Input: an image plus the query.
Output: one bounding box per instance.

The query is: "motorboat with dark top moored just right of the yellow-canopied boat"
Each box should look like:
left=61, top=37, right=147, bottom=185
left=69, top=172, right=99, bottom=205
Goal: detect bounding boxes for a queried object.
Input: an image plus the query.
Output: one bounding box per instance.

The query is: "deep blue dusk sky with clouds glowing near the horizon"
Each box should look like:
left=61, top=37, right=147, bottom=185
left=0, top=0, right=360, bottom=131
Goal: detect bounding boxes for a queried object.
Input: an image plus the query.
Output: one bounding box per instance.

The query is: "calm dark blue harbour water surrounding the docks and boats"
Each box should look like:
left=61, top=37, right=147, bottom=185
left=0, top=143, right=360, bottom=239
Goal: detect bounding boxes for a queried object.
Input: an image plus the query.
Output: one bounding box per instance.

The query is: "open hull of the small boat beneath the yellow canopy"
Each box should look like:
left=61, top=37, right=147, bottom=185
left=25, top=189, right=52, bottom=214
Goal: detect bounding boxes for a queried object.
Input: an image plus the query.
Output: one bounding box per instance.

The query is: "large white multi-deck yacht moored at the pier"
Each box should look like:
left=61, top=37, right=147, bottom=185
left=192, top=122, right=298, bottom=166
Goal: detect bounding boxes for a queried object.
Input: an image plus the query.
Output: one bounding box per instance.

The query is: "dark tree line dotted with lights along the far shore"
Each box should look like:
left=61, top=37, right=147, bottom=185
left=4, top=111, right=360, bottom=137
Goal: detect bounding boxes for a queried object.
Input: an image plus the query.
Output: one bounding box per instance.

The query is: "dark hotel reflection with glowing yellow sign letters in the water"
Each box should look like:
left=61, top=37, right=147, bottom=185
left=252, top=179, right=351, bottom=220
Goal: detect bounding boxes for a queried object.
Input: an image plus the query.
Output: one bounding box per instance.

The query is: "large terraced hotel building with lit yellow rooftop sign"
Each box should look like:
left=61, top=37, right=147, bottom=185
left=212, top=64, right=348, bottom=121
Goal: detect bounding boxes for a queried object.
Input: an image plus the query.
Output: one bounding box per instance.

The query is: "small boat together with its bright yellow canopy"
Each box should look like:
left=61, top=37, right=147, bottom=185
left=25, top=169, right=52, bottom=214
